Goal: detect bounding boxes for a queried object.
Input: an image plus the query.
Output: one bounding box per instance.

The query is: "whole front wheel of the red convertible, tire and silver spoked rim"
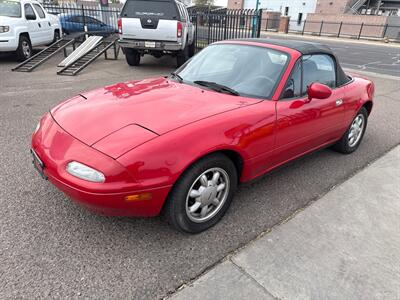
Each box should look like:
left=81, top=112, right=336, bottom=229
left=164, top=153, right=238, bottom=233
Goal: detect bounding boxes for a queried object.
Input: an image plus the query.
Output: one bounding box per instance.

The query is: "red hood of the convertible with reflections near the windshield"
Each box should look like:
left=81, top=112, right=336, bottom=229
left=51, top=77, right=260, bottom=152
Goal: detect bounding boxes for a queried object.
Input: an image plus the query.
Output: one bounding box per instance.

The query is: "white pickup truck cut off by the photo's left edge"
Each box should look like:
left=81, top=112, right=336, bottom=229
left=0, top=0, right=62, bottom=61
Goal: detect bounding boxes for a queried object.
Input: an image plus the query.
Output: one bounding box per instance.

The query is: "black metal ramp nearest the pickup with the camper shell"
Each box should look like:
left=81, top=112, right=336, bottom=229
left=57, top=38, right=119, bottom=76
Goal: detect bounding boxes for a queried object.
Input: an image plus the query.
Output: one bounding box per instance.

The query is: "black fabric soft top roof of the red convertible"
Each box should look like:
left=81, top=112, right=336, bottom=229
left=231, top=38, right=351, bottom=86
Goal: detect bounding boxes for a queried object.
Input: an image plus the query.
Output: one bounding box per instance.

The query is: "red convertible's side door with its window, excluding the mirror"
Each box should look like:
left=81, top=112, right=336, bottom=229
left=276, top=54, right=344, bottom=161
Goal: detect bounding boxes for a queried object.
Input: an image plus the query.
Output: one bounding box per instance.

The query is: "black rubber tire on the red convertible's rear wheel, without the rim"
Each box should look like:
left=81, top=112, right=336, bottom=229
left=332, top=107, right=368, bottom=154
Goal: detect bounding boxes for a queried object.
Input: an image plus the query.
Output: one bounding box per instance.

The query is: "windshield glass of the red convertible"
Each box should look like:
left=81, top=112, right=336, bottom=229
left=177, top=44, right=289, bottom=98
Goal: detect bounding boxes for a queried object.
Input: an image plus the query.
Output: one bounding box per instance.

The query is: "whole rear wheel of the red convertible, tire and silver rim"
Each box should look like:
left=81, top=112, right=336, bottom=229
left=333, top=107, right=368, bottom=154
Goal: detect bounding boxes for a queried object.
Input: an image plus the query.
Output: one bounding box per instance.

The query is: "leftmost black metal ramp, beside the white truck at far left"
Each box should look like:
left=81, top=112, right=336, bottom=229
left=12, top=38, right=75, bottom=72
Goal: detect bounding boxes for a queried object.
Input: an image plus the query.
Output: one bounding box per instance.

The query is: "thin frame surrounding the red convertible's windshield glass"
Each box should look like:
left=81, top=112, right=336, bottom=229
left=173, top=41, right=292, bottom=101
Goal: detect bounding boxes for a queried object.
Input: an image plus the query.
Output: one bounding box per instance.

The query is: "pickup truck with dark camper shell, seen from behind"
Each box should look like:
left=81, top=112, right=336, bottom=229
left=118, top=0, right=194, bottom=66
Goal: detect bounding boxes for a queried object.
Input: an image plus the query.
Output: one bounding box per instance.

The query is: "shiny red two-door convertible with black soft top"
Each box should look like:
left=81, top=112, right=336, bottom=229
left=31, top=39, right=374, bottom=233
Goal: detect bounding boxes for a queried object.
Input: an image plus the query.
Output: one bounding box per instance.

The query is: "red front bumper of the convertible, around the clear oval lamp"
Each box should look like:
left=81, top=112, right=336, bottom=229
left=32, top=114, right=171, bottom=217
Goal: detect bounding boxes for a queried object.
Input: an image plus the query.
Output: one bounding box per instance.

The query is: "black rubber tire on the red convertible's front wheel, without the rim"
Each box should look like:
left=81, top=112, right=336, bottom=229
left=163, top=153, right=238, bottom=233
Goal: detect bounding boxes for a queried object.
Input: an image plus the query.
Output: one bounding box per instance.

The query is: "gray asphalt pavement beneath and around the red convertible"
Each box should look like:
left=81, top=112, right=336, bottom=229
left=0, top=46, right=400, bottom=299
